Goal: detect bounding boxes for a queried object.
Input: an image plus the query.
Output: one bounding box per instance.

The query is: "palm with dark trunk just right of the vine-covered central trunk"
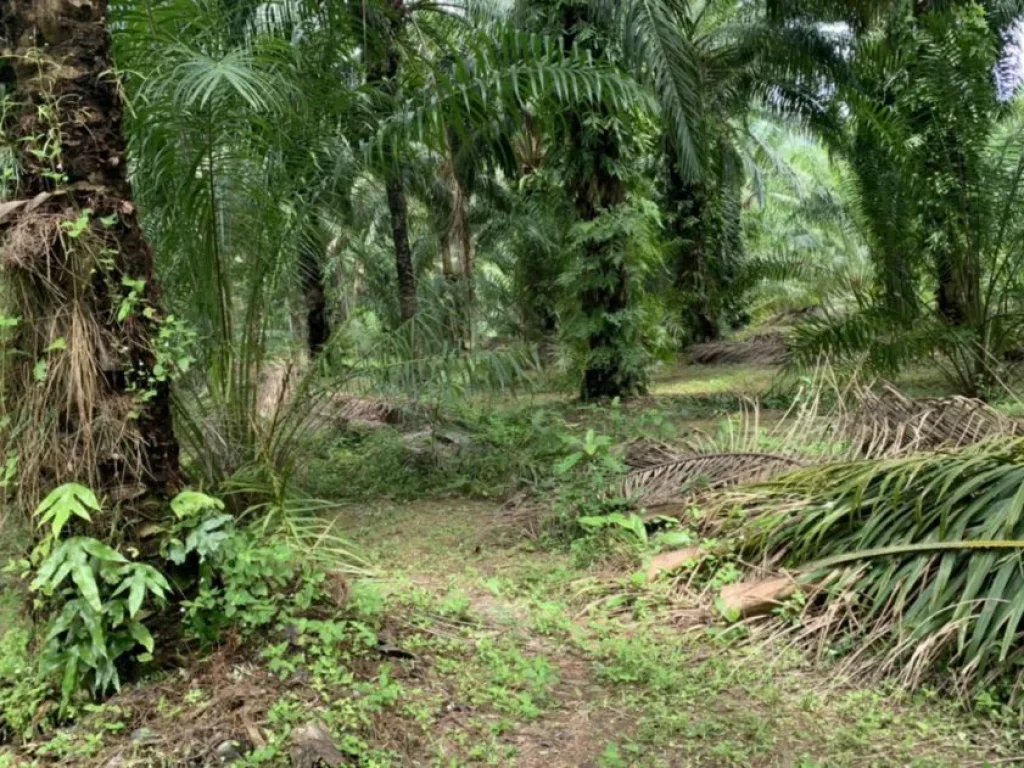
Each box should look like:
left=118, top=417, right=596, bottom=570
left=602, top=0, right=841, bottom=341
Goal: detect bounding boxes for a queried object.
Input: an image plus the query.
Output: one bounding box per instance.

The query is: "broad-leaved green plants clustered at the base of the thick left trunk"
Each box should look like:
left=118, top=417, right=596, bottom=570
left=0, top=483, right=348, bottom=737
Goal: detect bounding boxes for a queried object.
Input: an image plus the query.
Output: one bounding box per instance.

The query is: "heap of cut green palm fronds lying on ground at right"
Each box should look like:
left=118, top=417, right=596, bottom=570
left=732, top=438, right=1024, bottom=690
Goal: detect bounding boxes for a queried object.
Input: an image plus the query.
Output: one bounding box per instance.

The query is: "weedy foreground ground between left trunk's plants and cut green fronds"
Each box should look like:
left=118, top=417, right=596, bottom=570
left=9, top=500, right=1024, bottom=768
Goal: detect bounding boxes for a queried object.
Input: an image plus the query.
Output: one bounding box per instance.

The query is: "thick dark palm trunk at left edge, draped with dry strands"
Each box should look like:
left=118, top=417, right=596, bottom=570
left=0, top=0, right=182, bottom=510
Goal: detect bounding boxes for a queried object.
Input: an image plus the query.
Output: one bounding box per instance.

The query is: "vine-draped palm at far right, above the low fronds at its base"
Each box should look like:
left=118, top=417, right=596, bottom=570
left=767, top=0, right=1024, bottom=326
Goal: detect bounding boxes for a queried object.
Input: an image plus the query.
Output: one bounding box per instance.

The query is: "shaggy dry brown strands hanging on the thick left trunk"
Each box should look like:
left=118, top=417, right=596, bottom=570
left=0, top=217, right=148, bottom=518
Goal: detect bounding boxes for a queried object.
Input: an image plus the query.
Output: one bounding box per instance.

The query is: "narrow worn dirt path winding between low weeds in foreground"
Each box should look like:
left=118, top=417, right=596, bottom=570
left=348, top=503, right=636, bottom=768
